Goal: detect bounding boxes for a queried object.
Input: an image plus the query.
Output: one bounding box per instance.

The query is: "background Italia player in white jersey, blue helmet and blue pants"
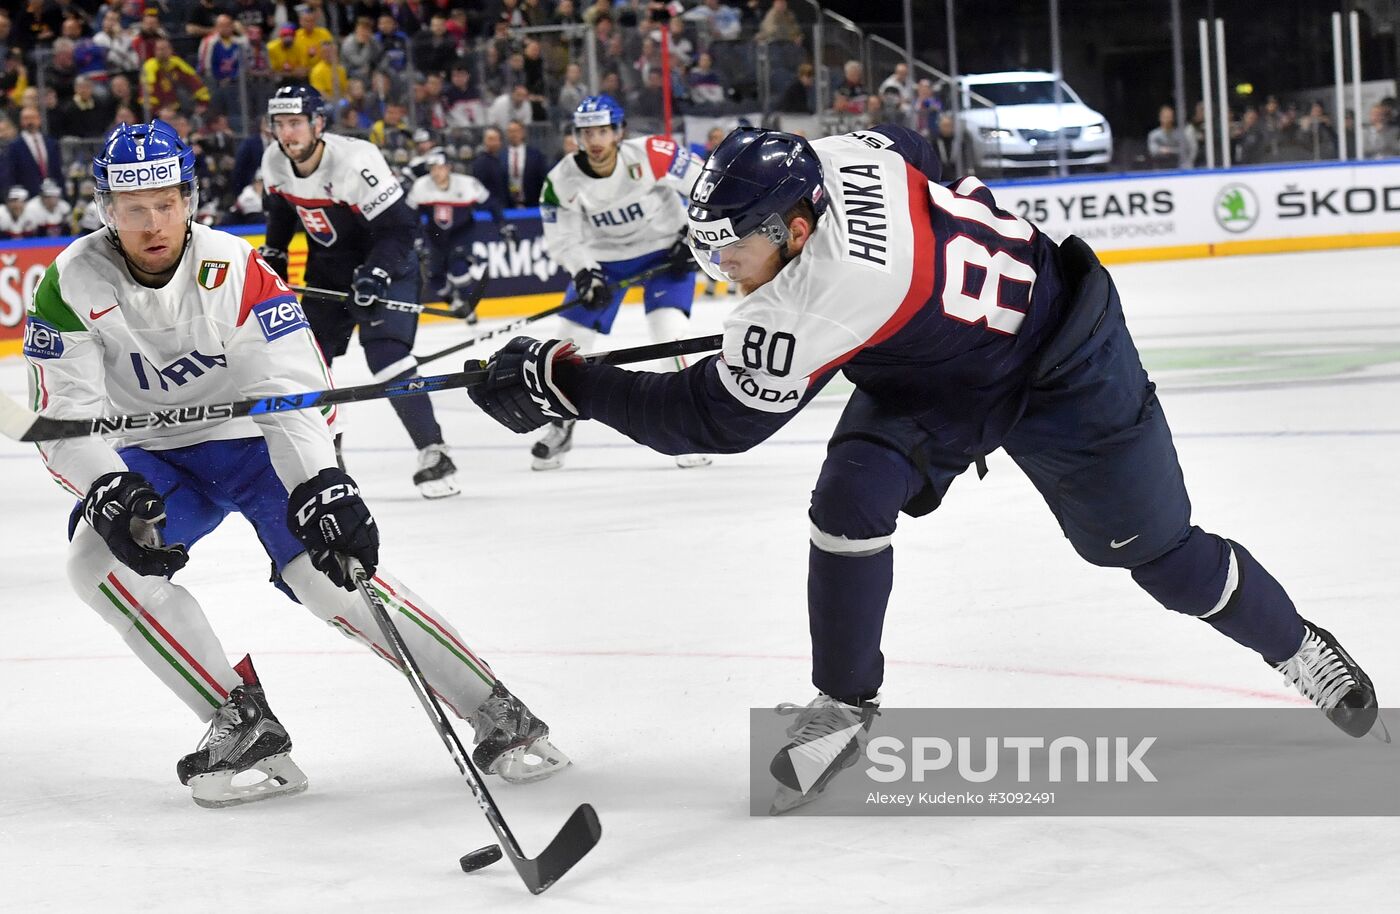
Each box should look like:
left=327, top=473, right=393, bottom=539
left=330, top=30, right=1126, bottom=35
left=531, top=95, right=710, bottom=470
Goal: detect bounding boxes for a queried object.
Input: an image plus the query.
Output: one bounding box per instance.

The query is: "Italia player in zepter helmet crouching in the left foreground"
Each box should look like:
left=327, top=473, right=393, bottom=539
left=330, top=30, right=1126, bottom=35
left=24, top=120, right=567, bottom=806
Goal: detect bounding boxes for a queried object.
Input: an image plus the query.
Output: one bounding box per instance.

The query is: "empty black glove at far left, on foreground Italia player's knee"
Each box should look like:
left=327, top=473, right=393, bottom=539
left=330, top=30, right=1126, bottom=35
left=83, top=470, right=189, bottom=578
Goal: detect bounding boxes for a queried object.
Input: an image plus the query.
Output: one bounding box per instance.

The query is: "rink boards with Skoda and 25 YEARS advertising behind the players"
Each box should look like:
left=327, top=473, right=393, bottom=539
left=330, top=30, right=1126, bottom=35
left=0, top=160, right=1400, bottom=356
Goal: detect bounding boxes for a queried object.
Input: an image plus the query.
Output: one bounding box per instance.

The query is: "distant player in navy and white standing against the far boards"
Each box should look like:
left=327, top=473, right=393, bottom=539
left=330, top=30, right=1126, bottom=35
left=409, top=150, right=515, bottom=323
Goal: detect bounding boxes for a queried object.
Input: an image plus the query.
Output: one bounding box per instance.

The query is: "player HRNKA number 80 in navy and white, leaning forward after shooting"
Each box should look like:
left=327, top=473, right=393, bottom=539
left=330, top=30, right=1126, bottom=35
left=470, top=126, right=1378, bottom=812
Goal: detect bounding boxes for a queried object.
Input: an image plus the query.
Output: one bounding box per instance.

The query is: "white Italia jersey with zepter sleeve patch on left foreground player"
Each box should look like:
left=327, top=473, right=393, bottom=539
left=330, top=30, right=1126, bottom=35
left=24, top=224, right=336, bottom=495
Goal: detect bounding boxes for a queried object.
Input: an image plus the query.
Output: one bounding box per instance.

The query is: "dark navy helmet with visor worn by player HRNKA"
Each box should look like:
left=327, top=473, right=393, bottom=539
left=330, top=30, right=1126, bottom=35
left=686, top=127, right=827, bottom=280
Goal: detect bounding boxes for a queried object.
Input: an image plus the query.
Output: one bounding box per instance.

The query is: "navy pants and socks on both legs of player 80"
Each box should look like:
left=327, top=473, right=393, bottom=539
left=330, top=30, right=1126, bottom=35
left=808, top=261, right=1302, bottom=703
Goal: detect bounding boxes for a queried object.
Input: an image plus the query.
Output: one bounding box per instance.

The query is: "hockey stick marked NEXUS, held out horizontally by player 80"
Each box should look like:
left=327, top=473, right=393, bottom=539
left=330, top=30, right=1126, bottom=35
left=0, top=335, right=724, bottom=441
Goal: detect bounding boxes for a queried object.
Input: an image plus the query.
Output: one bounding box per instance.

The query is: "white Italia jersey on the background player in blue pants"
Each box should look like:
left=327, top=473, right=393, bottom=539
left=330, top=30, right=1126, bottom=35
left=539, top=136, right=704, bottom=274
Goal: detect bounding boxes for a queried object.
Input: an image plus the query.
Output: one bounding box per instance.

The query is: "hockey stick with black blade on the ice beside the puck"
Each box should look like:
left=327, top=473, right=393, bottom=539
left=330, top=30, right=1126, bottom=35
left=350, top=558, right=603, bottom=894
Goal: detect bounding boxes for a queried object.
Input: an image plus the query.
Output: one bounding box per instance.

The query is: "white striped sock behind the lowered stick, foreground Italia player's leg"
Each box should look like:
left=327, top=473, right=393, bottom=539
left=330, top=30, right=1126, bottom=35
left=281, top=554, right=496, bottom=719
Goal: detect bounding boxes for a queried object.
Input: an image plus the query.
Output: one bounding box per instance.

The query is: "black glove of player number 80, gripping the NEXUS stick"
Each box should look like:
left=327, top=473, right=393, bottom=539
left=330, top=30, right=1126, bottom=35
left=466, top=336, right=582, bottom=433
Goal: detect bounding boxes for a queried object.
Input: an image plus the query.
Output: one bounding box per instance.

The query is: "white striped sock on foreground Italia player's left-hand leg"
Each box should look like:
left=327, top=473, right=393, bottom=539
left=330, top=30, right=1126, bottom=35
left=69, top=523, right=242, bottom=721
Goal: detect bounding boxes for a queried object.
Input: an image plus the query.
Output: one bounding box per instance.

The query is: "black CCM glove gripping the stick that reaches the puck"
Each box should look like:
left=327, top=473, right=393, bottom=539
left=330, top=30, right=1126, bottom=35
left=287, top=466, right=379, bottom=591
